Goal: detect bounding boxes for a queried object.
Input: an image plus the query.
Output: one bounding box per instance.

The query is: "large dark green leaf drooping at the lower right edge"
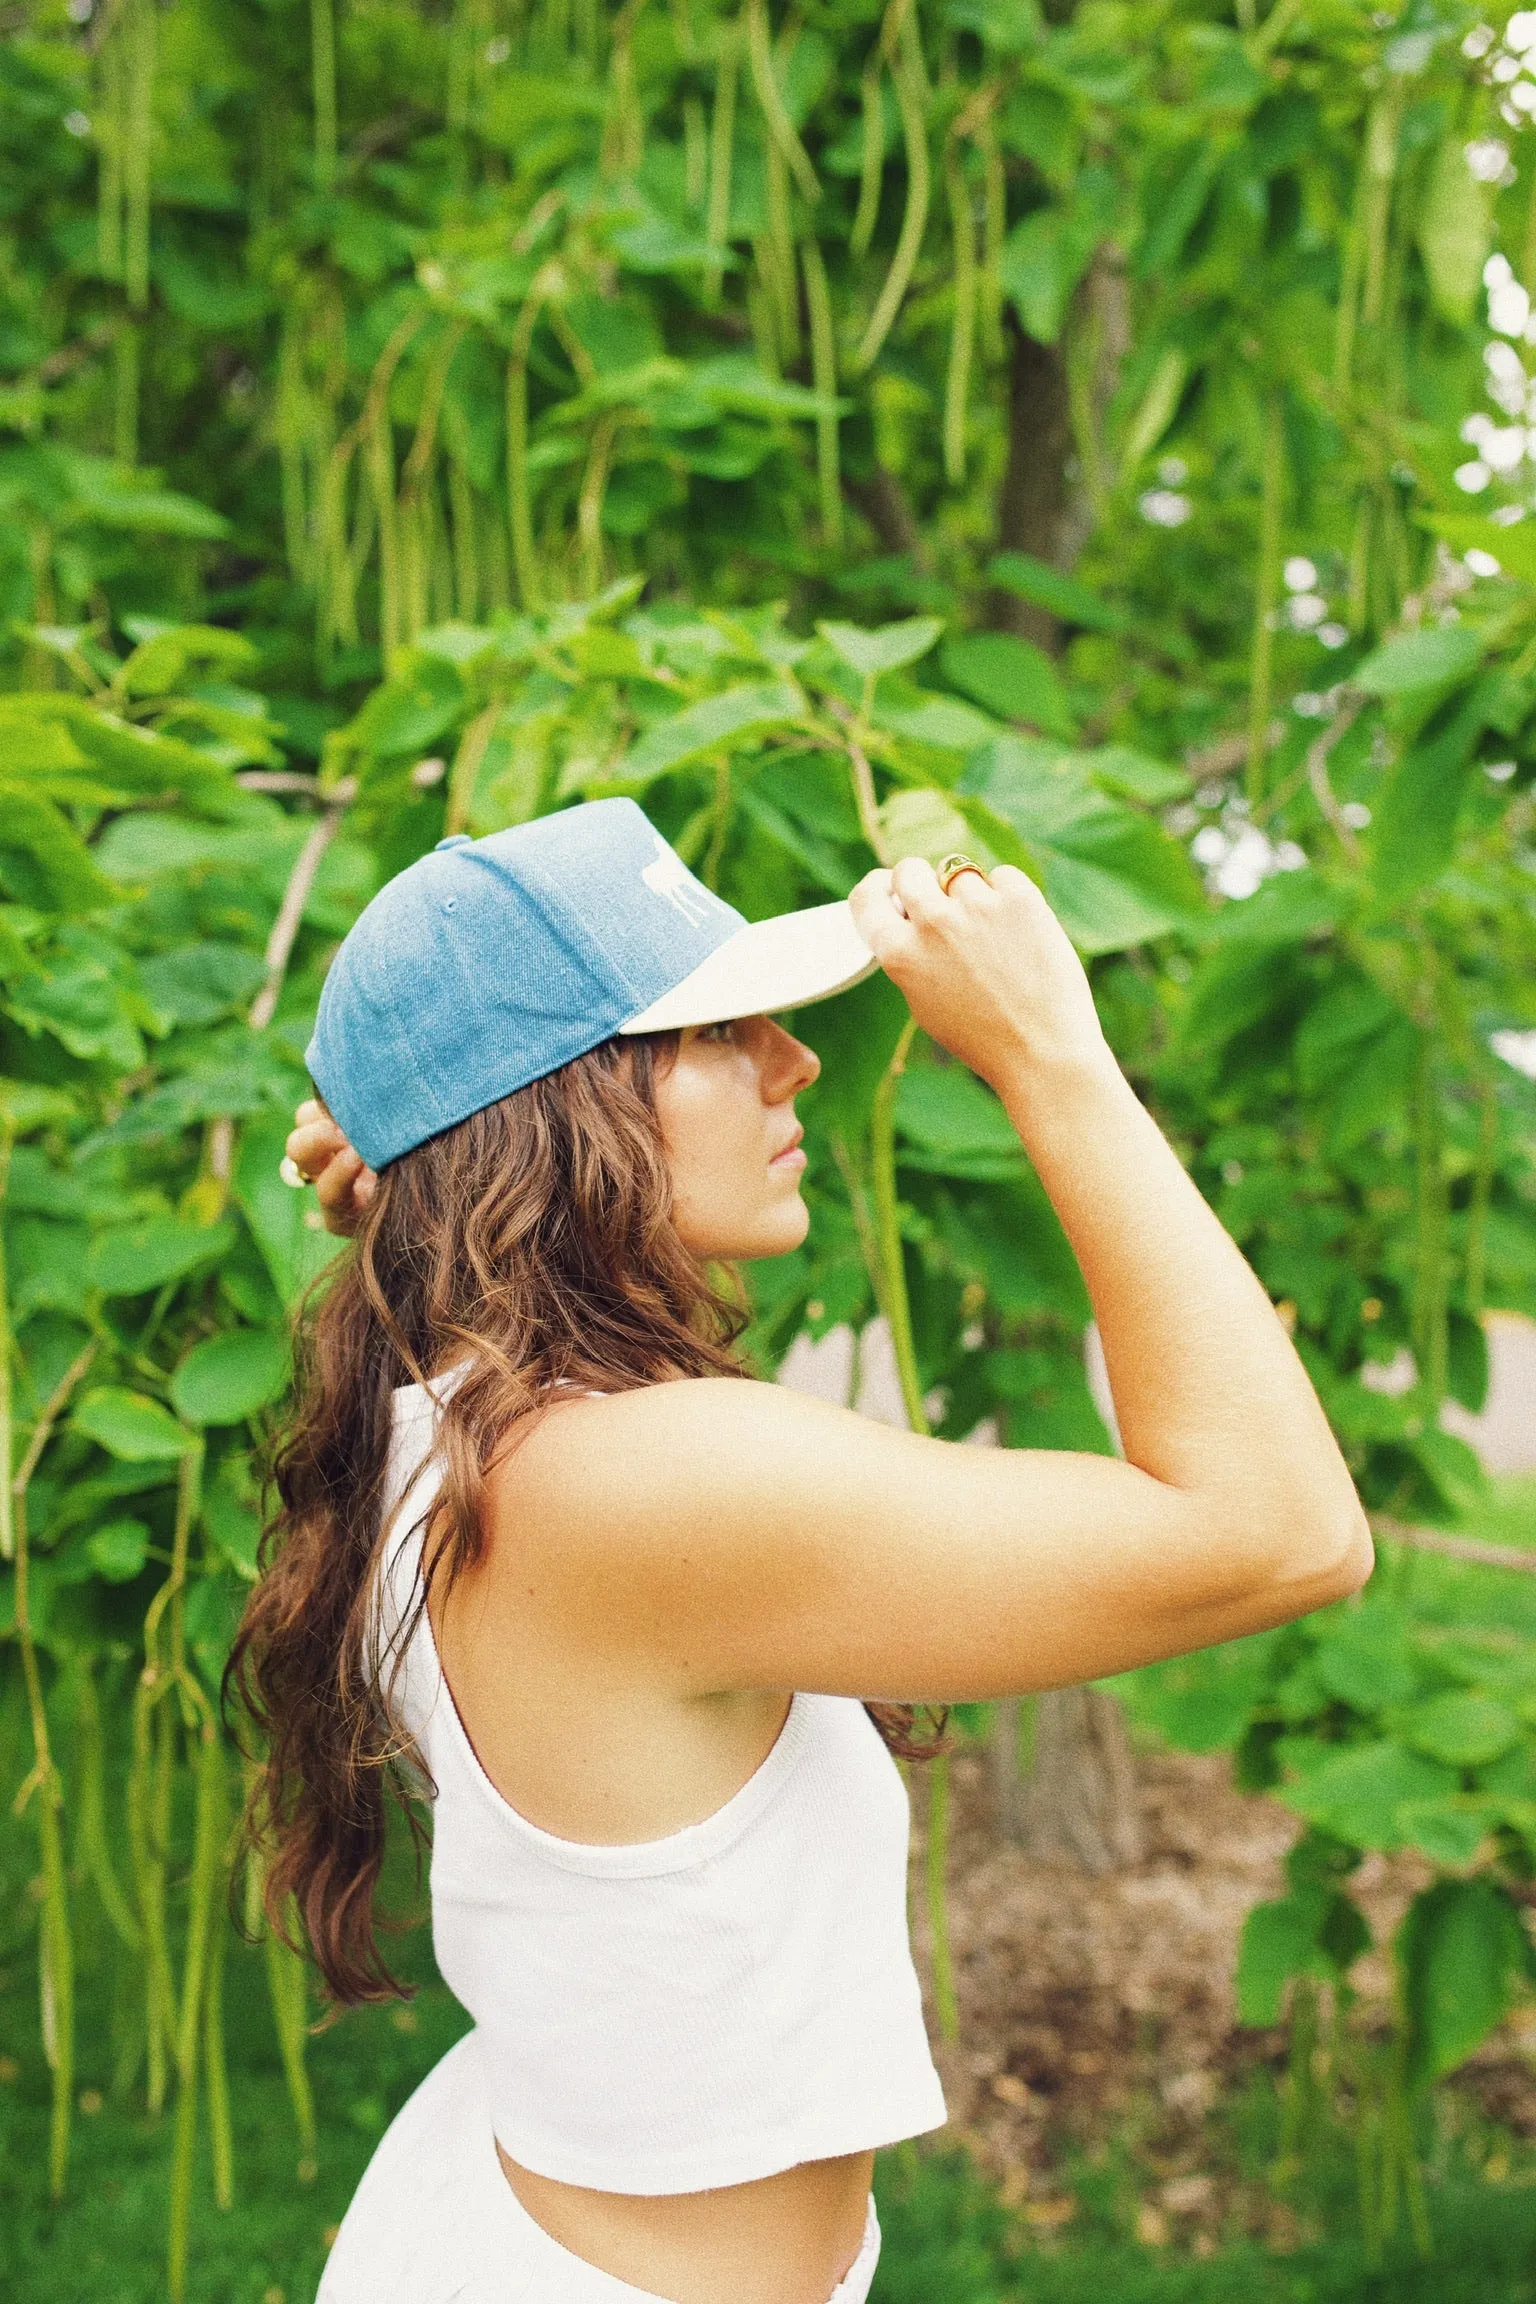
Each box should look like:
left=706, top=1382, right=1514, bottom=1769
left=1393, top=1880, right=1531, bottom=2087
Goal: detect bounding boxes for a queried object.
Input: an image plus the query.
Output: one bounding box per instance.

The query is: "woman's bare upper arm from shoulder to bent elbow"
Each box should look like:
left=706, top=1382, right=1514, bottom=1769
left=493, top=1380, right=1359, bottom=1700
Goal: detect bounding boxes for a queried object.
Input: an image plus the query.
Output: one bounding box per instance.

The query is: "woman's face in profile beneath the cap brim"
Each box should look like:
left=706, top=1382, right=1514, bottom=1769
left=654, top=1016, right=822, bottom=1258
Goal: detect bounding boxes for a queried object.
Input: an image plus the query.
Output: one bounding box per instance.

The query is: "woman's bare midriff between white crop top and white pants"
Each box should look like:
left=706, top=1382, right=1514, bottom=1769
left=497, top=2145, right=875, bottom=2304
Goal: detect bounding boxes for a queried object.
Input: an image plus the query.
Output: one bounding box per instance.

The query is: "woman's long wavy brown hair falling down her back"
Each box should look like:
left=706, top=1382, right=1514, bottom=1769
left=226, top=1034, right=944, bottom=2004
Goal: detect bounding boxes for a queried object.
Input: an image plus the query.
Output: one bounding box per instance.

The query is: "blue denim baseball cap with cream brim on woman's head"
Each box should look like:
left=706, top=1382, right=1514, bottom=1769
left=306, top=799, right=875, bottom=1168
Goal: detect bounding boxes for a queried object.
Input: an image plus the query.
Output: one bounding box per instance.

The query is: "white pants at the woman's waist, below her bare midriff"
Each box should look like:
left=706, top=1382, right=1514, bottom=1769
left=315, top=2032, right=880, bottom=2304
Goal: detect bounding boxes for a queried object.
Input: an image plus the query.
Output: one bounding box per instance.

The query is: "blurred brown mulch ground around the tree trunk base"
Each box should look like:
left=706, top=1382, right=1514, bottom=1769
left=912, top=1749, right=1536, bottom=2253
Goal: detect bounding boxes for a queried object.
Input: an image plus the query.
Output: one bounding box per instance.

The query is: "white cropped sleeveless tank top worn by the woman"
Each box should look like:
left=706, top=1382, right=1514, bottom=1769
left=380, top=1385, right=946, bottom=2193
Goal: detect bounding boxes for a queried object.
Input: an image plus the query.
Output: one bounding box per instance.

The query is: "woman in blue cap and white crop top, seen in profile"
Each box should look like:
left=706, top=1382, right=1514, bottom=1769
left=235, top=799, right=1370, bottom=2304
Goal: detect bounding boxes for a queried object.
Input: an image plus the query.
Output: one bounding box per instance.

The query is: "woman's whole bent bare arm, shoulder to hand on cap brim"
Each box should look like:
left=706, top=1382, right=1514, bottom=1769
left=493, top=862, right=1372, bottom=1698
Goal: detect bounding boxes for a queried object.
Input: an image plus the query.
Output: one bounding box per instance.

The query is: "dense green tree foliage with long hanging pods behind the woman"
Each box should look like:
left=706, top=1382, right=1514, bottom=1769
left=0, top=0, right=1536, bottom=2297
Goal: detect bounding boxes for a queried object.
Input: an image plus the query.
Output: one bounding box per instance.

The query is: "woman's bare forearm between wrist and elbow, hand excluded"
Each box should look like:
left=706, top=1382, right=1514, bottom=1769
left=997, top=1048, right=1363, bottom=1541
